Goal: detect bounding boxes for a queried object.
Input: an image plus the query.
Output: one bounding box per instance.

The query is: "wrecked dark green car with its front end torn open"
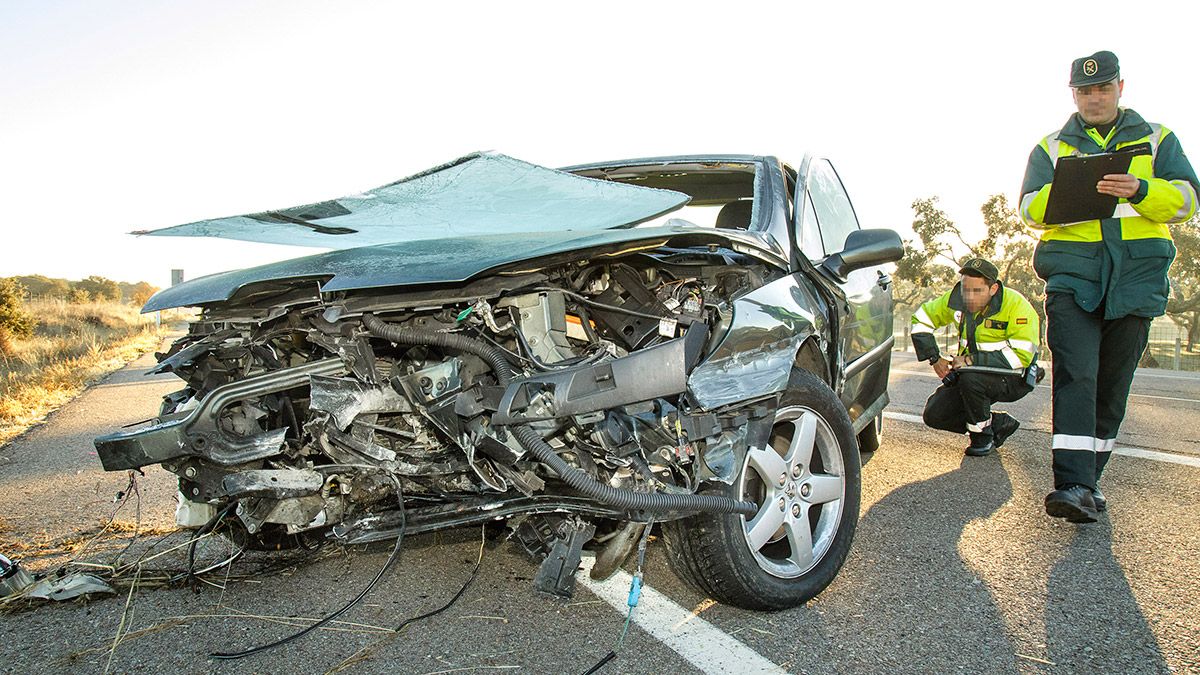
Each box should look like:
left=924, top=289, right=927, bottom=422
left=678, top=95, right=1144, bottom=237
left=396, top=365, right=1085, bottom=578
left=95, top=154, right=901, bottom=609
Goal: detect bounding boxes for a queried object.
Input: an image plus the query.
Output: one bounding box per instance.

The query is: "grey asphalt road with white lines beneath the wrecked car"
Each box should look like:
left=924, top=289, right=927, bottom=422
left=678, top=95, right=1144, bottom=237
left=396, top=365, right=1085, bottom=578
left=0, top=343, right=1200, bottom=674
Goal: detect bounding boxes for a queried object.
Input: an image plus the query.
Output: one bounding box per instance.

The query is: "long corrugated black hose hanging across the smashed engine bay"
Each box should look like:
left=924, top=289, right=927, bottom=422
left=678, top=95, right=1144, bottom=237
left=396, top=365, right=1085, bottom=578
left=362, top=313, right=758, bottom=515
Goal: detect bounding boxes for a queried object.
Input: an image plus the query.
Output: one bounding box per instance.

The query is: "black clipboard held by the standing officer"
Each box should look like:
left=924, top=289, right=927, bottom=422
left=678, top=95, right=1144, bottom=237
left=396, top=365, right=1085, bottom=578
left=1044, top=144, right=1151, bottom=225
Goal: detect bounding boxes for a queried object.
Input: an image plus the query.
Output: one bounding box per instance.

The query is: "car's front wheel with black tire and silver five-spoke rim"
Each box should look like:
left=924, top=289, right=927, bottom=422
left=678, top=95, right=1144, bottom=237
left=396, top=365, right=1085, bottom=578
left=662, top=371, right=860, bottom=610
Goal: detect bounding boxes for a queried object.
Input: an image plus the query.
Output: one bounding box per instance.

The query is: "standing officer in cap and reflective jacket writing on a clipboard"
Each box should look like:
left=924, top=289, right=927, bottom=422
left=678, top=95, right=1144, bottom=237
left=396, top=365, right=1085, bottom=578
left=1021, top=52, right=1200, bottom=522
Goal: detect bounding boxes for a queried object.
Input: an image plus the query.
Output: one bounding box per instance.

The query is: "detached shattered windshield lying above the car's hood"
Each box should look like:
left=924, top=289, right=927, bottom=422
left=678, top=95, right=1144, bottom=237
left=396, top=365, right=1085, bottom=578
left=134, top=154, right=689, bottom=249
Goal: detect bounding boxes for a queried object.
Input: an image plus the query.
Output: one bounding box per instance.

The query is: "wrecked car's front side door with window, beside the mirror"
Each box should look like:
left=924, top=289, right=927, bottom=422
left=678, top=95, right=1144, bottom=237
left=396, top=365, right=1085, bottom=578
left=794, top=159, right=894, bottom=431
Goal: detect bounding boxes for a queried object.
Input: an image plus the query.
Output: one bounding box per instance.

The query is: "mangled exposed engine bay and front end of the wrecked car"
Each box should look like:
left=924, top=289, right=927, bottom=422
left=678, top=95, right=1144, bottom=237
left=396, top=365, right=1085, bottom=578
left=97, top=246, right=796, bottom=595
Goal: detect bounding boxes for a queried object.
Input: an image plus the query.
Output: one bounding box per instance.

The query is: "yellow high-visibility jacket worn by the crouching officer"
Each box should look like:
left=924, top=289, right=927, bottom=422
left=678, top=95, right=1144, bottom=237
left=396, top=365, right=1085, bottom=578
left=912, top=283, right=1042, bottom=372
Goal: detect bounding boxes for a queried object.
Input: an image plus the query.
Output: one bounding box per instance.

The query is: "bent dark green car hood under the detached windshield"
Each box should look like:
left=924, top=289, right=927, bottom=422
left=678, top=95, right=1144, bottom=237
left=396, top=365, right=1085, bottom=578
left=142, top=225, right=786, bottom=312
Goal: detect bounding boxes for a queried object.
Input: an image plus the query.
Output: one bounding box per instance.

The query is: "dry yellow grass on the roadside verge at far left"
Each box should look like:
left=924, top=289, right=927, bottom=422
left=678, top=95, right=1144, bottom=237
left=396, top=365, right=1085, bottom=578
left=0, top=300, right=180, bottom=447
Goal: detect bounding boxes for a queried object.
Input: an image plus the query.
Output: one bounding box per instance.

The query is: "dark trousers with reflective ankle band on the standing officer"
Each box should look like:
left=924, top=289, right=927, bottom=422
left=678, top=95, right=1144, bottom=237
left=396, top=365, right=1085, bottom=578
left=1046, top=293, right=1150, bottom=490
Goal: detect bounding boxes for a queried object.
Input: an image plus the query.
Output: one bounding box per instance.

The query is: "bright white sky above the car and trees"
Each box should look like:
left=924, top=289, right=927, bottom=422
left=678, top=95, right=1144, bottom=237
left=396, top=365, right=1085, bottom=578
left=0, top=0, right=1200, bottom=286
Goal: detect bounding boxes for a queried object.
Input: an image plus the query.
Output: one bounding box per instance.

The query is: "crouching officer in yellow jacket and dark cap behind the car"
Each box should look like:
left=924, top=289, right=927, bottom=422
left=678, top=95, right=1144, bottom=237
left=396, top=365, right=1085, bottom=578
left=912, top=258, right=1040, bottom=456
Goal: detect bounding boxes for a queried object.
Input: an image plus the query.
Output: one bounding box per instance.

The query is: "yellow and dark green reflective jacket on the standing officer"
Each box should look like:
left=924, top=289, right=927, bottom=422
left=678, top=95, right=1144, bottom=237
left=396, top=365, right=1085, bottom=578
left=1020, top=108, right=1200, bottom=318
